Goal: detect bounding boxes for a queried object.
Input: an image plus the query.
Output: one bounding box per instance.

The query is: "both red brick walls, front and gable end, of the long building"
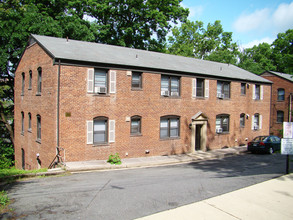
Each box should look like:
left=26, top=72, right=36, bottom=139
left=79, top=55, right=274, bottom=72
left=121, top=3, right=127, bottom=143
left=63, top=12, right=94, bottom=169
left=15, top=45, right=271, bottom=168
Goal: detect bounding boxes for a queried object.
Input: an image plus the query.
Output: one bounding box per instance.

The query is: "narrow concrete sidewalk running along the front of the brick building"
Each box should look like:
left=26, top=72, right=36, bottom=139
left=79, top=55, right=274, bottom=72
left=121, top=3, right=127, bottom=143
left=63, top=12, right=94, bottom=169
left=65, top=146, right=247, bottom=172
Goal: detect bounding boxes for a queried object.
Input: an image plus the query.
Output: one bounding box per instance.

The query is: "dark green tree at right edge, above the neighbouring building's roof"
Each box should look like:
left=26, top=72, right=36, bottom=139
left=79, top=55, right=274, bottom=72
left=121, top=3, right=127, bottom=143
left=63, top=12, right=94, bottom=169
left=272, top=29, right=293, bottom=74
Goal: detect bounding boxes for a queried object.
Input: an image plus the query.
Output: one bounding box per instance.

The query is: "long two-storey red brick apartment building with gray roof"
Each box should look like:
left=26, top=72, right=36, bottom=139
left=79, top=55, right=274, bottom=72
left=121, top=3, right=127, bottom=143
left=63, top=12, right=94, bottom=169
left=15, top=35, right=271, bottom=169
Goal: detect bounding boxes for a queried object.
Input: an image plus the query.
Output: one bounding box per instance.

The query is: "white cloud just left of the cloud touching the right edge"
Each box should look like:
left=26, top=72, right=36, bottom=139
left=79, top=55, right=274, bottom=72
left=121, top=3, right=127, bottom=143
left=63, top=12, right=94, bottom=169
left=233, top=8, right=270, bottom=32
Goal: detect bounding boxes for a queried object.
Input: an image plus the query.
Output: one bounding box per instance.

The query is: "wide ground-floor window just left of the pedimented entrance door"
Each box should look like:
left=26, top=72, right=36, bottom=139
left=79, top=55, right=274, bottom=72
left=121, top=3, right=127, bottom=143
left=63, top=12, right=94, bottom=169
left=160, top=116, right=180, bottom=139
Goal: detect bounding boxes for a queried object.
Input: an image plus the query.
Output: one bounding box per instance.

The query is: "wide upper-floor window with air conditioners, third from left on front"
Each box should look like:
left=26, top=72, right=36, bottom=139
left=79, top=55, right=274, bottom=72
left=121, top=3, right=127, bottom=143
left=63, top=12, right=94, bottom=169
left=161, top=75, right=180, bottom=97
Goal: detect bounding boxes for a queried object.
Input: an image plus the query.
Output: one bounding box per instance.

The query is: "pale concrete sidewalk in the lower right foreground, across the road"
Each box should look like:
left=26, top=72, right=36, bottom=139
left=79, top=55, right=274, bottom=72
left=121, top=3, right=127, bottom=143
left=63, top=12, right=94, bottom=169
left=139, top=174, right=293, bottom=220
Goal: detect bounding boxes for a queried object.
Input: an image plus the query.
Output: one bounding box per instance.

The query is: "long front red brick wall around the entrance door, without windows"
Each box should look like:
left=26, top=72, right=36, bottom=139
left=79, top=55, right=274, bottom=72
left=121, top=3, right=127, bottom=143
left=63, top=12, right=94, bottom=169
left=61, top=66, right=271, bottom=161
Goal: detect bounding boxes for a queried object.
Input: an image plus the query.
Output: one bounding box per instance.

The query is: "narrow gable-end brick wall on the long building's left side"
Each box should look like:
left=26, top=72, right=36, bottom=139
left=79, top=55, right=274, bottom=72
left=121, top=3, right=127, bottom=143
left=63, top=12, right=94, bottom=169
left=14, top=44, right=57, bottom=169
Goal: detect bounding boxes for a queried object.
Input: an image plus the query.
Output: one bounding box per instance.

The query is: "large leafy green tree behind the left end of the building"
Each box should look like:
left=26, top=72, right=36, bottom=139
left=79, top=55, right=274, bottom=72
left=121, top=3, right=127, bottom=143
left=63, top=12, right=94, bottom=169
left=0, top=0, right=188, bottom=167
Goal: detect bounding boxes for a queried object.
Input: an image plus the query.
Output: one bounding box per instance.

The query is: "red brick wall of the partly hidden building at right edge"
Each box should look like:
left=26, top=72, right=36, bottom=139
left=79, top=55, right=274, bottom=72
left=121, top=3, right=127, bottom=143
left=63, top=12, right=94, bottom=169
left=262, top=73, right=293, bottom=137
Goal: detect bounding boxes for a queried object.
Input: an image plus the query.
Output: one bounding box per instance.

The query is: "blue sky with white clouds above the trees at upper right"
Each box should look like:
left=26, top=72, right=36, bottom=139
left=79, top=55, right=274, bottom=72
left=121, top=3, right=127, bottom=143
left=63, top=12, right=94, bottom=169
left=181, top=0, right=293, bottom=48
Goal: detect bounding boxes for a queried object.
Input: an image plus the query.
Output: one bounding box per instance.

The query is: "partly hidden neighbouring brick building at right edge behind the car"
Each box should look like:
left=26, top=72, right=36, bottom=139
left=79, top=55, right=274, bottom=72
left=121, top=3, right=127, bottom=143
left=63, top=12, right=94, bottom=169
left=261, top=71, right=293, bottom=137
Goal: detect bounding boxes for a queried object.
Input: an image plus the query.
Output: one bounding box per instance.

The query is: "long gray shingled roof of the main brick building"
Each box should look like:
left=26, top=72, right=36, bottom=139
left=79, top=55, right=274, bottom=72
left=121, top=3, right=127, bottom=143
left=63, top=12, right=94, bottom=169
left=31, top=35, right=271, bottom=83
